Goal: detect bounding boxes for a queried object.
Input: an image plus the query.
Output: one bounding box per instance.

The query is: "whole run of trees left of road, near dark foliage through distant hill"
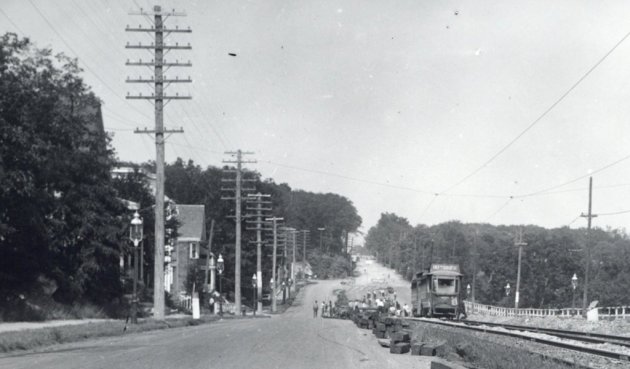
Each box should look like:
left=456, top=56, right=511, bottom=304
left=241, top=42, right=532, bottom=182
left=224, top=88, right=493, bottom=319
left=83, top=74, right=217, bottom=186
left=0, top=34, right=361, bottom=320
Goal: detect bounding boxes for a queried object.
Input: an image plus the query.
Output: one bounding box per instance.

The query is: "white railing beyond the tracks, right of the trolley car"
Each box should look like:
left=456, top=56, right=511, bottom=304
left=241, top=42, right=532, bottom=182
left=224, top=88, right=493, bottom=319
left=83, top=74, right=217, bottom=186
left=464, top=300, right=630, bottom=320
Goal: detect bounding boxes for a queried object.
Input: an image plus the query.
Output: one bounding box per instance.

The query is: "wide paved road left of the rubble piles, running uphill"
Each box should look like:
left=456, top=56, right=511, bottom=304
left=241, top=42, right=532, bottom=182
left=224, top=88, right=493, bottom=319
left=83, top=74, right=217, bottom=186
left=0, top=260, right=430, bottom=369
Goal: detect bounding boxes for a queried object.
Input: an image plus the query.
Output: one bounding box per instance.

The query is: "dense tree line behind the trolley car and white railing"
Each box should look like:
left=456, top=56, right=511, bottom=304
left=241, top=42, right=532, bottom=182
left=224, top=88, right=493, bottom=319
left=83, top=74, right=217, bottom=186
left=366, top=213, right=630, bottom=308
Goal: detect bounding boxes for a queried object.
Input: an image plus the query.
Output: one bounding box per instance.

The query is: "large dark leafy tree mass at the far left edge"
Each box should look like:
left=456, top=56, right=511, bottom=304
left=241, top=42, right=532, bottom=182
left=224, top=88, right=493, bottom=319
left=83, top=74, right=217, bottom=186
left=0, top=34, right=124, bottom=318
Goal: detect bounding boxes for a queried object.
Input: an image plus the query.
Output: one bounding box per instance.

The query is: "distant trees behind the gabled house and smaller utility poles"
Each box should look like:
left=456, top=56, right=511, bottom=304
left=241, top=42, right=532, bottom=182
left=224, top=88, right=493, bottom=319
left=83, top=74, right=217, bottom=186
left=165, top=158, right=361, bottom=298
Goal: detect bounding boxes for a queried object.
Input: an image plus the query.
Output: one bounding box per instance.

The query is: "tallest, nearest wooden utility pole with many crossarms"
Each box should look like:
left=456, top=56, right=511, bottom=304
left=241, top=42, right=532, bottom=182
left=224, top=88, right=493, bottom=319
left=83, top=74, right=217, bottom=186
left=125, top=6, right=192, bottom=319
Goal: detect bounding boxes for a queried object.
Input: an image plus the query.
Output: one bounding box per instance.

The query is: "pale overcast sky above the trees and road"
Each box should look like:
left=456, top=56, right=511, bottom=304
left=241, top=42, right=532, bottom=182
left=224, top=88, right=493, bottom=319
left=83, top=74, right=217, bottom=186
left=0, top=0, right=630, bottom=239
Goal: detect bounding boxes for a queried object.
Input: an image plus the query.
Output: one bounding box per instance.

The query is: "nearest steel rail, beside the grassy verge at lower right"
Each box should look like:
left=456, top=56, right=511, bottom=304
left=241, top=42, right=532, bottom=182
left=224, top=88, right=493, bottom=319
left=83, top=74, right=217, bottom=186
left=404, top=318, right=630, bottom=362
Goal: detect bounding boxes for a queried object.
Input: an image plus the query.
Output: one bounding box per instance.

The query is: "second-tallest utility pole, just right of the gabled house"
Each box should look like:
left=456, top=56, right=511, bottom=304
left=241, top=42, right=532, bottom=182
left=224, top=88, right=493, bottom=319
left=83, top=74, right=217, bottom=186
left=221, top=150, right=256, bottom=314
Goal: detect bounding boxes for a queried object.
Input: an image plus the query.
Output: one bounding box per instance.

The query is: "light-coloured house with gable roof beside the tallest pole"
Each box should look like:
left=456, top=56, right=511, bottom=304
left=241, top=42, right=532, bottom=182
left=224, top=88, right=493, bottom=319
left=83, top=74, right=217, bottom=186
left=164, top=204, right=206, bottom=297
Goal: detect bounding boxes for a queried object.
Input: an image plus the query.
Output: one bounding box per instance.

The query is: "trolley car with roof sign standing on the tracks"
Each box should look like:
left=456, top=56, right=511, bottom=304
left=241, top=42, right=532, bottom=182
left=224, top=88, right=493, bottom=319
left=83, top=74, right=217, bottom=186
left=411, top=264, right=464, bottom=319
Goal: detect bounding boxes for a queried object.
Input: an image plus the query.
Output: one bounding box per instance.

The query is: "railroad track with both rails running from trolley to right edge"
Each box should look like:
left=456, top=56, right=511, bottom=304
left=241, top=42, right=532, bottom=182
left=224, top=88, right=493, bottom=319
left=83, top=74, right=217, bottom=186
left=404, top=318, right=630, bottom=362
